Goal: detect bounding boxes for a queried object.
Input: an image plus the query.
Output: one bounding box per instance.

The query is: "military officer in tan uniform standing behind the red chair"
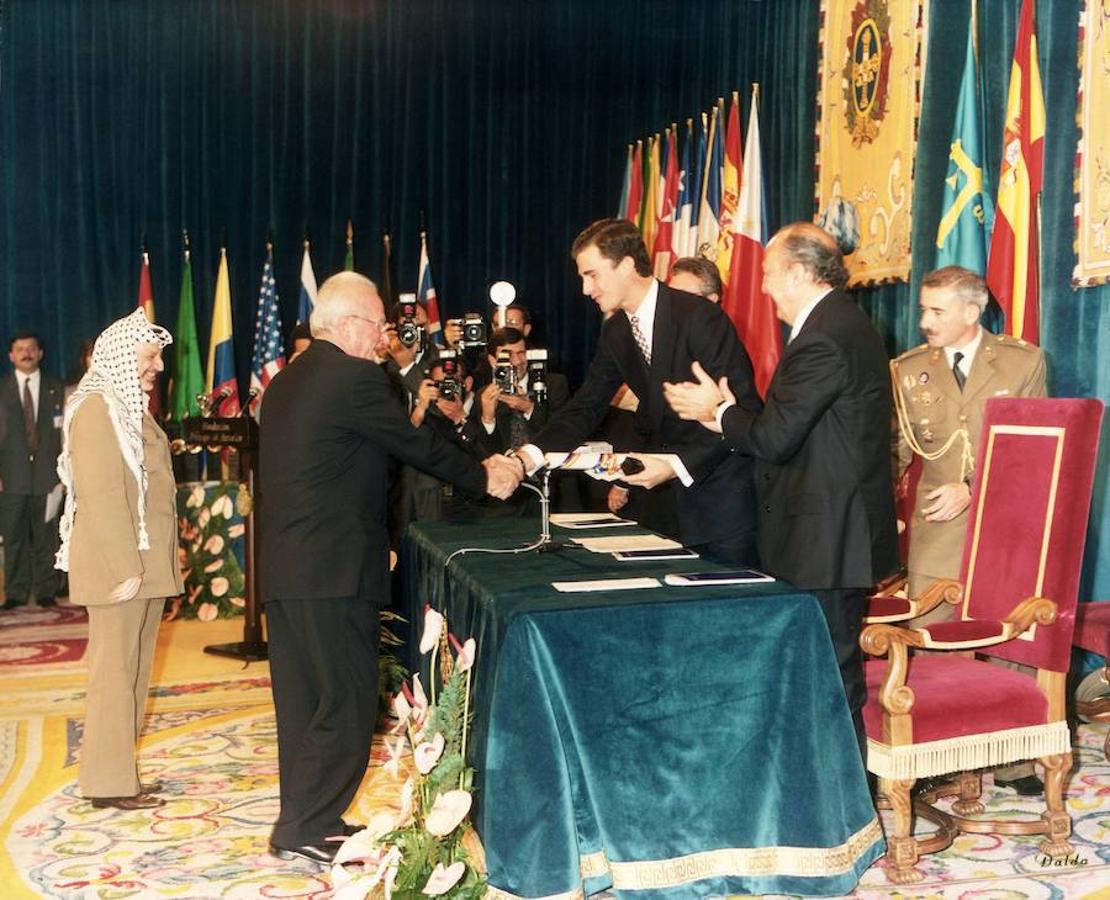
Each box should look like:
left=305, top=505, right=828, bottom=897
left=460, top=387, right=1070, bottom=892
left=891, top=265, right=1046, bottom=795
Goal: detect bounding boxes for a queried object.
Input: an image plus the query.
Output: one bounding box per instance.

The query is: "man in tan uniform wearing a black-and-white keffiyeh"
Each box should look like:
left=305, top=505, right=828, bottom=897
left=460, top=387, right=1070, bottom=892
left=57, top=309, right=183, bottom=809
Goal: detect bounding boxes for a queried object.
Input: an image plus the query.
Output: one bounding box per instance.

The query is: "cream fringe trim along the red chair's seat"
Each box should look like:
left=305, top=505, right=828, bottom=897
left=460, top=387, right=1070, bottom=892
left=867, top=721, right=1071, bottom=781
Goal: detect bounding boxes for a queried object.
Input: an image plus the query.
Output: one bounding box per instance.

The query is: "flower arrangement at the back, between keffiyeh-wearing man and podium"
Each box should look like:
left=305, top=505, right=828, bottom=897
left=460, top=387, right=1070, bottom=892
left=170, top=482, right=246, bottom=621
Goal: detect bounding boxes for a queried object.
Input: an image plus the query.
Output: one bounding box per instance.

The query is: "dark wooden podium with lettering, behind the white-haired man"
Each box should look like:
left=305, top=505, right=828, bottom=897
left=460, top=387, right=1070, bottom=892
left=183, top=416, right=269, bottom=663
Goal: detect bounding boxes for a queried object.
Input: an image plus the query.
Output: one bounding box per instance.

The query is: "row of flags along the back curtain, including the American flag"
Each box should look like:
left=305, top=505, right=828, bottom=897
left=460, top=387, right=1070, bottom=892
left=130, top=222, right=443, bottom=421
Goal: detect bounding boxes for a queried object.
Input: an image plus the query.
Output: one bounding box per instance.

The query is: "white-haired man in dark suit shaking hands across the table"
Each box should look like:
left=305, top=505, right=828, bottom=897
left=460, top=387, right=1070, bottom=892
left=259, top=272, right=519, bottom=864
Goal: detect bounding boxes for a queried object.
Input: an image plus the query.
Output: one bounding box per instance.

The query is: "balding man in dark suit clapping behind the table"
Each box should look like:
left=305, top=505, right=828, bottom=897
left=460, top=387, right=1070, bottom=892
left=666, top=222, right=898, bottom=760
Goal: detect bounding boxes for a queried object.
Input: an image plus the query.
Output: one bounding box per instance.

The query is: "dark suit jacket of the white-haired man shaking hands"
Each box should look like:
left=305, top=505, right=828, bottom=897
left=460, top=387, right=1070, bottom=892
left=259, top=340, right=486, bottom=604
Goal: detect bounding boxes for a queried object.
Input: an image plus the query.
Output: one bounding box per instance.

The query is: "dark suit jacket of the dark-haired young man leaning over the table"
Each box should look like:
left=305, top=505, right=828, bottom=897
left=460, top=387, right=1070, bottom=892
left=533, top=284, right=760, bottom=544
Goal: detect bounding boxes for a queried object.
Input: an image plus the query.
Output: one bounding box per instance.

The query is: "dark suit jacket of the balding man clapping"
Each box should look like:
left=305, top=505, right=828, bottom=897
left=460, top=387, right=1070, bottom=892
left=722, top=291, right=898, bottom=589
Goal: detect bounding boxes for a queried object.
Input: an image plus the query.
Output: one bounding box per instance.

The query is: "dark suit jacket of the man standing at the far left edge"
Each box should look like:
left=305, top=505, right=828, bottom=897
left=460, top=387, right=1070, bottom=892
left=0, top=372, right=64, bottom=494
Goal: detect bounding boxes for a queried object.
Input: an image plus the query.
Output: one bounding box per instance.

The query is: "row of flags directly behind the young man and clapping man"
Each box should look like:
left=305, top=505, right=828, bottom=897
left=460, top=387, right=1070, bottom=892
left=618, top=84, right=783, bottom=395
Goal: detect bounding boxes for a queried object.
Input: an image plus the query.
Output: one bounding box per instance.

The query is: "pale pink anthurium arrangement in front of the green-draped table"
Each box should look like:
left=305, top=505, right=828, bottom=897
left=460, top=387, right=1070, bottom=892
left=332, top=606, right=486, bottom=900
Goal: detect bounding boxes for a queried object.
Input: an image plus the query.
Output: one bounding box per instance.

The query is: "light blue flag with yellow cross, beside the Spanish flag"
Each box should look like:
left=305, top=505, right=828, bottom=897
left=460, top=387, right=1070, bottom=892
left=937, top=20, right=995, bottom=275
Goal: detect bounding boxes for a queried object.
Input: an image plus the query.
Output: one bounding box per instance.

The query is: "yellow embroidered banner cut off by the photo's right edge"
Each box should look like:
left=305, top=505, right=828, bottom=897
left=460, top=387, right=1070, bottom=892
left=1071, top=0, right=1110, bottom=287
